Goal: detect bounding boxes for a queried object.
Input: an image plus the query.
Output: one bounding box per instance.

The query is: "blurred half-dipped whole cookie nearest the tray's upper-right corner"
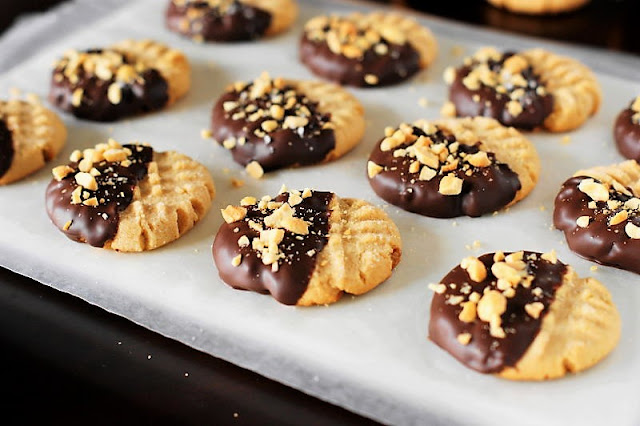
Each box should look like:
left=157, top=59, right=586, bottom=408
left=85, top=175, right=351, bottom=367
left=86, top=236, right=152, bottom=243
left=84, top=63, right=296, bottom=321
left=443, top=47, right=602, bottom=132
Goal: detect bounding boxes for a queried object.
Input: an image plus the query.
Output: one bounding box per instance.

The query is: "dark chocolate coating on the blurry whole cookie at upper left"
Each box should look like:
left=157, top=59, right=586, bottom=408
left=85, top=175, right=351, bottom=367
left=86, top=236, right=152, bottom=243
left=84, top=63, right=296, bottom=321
left=49, top=49, right=169, bottom=121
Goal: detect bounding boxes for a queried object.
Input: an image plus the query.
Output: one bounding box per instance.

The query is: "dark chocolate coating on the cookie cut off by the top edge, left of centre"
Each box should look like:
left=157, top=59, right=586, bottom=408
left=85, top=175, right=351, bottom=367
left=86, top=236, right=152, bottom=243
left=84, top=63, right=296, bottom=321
left=166, top=1, right=271, bottom=41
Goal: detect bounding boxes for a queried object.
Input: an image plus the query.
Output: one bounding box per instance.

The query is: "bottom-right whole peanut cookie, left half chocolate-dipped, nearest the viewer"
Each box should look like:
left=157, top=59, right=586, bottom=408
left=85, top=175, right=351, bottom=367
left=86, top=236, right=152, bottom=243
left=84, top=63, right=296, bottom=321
left=429, top=251, right=620, bottom=380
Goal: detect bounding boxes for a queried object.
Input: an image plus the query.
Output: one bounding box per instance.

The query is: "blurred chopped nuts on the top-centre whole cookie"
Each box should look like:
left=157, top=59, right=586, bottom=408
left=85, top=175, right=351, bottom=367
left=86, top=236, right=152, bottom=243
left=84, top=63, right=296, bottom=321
left=305, top=14, right=407, bottom=67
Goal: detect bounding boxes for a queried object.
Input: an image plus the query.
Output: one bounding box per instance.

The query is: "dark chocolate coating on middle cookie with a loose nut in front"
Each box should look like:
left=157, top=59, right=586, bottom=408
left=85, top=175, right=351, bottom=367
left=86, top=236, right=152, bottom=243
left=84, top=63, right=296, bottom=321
left=211, top=86, right=336, bottom=172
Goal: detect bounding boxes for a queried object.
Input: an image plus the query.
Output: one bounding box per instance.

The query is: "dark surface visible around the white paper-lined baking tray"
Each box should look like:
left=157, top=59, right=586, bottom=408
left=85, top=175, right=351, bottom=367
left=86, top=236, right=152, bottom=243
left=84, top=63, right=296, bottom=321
left=0, top=0, right=640, bottom=425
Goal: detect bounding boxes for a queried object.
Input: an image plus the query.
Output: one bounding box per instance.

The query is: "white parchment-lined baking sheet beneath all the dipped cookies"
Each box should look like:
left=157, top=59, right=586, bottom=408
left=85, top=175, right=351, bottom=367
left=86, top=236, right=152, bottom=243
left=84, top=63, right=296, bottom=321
left=0, top=0, right=640, bottom=425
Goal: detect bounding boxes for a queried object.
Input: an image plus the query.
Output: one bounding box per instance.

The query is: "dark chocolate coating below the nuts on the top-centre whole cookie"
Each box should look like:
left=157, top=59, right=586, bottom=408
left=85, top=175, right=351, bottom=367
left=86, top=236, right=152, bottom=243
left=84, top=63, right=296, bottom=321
left=300, top=34, right=420, bottom=87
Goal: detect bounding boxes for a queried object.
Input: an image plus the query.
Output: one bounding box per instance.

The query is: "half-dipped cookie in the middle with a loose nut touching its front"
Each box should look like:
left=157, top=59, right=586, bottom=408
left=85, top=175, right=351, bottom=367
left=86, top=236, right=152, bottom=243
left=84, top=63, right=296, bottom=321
left=211, top=73, right=365, bottom=174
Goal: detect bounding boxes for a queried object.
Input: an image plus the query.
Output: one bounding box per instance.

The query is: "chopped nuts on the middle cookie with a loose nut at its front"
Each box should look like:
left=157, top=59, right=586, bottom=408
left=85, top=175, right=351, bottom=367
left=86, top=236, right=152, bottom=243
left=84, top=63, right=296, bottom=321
left=222, top=72, right=333, bottom=149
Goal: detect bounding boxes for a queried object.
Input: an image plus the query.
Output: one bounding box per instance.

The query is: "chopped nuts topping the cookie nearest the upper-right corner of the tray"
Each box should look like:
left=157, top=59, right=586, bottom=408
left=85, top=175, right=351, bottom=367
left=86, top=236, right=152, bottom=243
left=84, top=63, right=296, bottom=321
left=444, top=47, right=547, bottom=117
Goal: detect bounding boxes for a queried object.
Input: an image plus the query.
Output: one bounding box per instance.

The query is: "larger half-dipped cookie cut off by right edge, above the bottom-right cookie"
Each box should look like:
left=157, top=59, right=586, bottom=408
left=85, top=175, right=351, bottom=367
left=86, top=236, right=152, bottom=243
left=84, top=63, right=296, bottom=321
left=553, top=160, right=640, bottom=274
